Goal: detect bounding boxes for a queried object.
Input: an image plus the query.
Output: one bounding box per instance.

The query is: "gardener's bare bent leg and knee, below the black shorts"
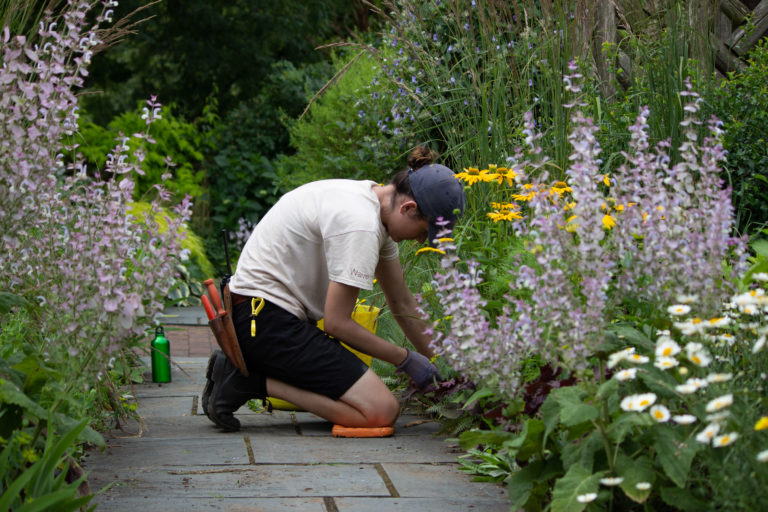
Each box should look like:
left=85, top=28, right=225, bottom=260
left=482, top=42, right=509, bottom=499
left=267, top=370, right=400, bottom=427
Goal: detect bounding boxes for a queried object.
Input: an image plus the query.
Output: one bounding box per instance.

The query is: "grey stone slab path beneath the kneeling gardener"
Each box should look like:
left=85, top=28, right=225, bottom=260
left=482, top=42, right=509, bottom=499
left=85, top=310, right=509, bottom=512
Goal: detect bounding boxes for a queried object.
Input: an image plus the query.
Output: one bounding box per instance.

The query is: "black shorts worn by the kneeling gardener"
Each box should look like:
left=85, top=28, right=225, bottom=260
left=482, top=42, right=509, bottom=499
left=232, top=300, right=368, bottom=400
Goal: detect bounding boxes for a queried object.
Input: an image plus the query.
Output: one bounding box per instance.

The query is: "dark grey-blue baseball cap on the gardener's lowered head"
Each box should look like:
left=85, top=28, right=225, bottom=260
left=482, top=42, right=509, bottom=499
left=408, top=164, right=466, bottom=246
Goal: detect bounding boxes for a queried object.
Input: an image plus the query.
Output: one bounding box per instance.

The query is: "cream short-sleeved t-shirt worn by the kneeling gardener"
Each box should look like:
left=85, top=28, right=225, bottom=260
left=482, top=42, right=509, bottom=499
left=229, top=180, right=398, bottom=320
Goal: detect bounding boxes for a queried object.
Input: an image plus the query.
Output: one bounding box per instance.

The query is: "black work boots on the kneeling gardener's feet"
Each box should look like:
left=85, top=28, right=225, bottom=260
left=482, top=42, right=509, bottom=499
left=203, top=350, right=267, bottom=432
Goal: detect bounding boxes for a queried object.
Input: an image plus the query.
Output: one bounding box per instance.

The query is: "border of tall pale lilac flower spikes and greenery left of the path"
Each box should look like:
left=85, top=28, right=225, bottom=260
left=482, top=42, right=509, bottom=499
left=0, top=0, right=191, bottom=504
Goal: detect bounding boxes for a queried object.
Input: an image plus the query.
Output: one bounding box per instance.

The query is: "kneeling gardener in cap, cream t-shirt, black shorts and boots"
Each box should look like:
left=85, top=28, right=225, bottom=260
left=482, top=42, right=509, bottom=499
left=203, top=147, right=465, bottom=430
